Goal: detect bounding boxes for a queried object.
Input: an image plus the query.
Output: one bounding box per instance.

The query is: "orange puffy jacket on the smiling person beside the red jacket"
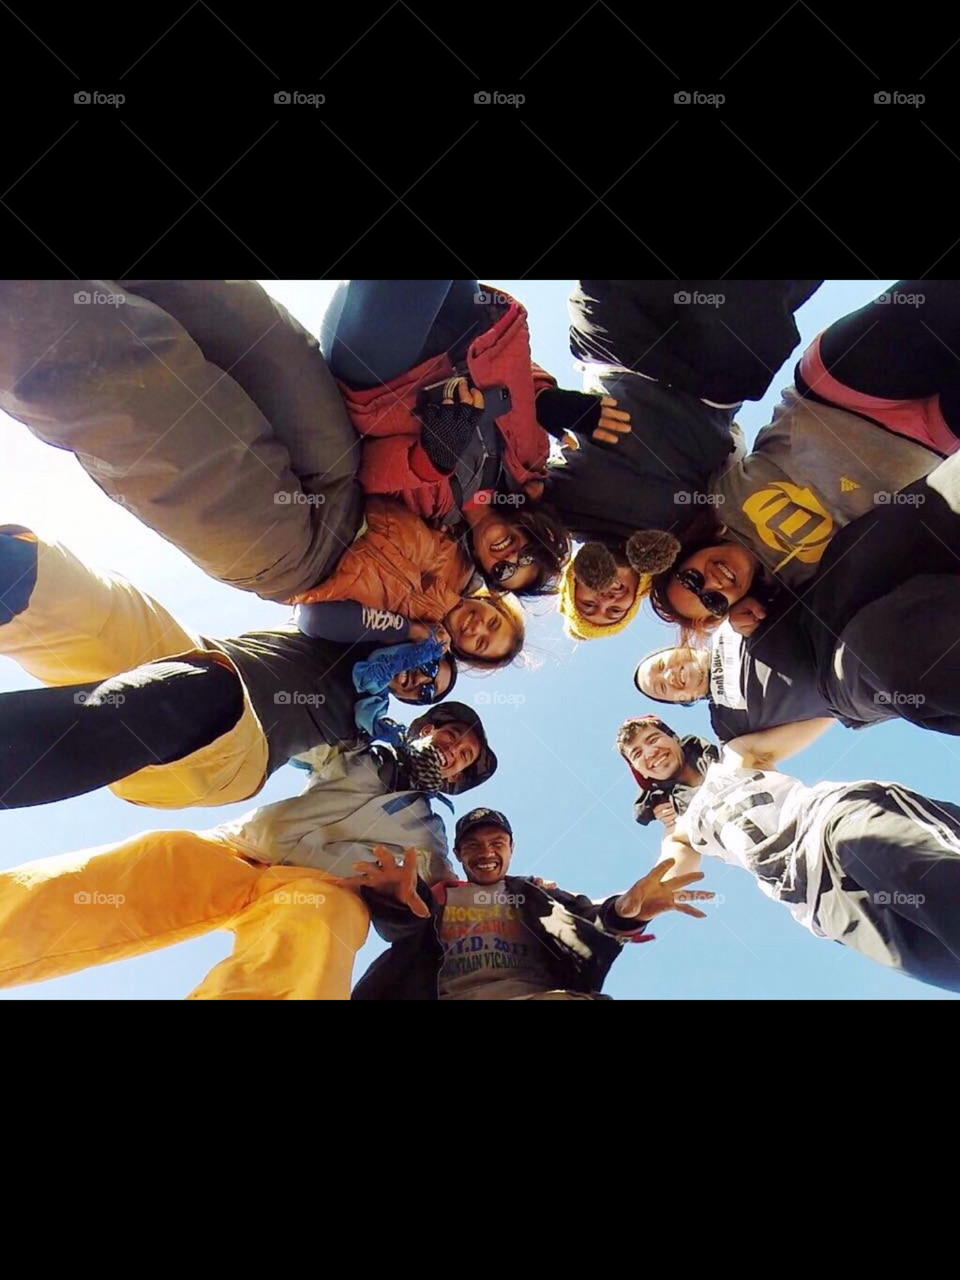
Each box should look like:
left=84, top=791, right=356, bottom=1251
left=291, top=498, right=474, bottom=622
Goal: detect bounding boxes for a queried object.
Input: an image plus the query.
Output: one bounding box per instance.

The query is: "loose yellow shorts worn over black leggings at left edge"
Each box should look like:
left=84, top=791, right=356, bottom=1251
left=0, top=525, right=269, bottom=809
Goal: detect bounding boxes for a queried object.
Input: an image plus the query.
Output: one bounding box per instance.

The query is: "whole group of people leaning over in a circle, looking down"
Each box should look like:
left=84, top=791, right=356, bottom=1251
left=0, top=280, right=960, bottom=998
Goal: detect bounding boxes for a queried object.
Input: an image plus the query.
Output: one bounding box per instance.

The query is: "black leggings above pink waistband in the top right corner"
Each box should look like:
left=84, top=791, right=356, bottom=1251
left=820, top=280, right=960, bottom=435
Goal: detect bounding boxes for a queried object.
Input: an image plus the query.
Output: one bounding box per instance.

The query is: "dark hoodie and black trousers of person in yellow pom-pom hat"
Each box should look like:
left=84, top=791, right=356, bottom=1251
left=544, top=280, right=820, bottom=540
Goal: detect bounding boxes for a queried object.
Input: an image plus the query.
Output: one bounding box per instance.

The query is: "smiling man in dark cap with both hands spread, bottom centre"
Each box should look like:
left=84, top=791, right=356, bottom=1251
left=353, top=809, right=709, bottom=1000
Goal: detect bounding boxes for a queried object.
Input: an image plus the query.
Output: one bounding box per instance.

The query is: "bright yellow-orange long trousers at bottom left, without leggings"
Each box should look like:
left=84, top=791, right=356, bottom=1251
left=0, top=829, right=370, bottom=1000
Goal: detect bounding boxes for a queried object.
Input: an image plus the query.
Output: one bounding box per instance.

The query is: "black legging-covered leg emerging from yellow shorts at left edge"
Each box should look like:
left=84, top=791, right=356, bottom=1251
left=0, top=658, right=243, bottom=809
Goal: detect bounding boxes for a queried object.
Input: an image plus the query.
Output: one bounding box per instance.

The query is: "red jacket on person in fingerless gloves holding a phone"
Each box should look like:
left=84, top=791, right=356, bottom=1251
left=339, top=288, right=556, bottom=518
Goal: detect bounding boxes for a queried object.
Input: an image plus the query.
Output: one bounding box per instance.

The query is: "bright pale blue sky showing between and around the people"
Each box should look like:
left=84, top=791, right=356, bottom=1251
left=0, top=276, right=960, bottom=1000
